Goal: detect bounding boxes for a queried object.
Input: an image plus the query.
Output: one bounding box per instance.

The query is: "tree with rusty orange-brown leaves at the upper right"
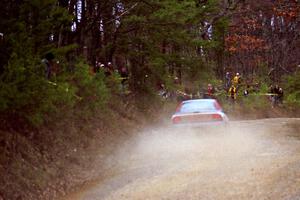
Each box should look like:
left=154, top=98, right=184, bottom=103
left=226, top=0, right=300, bottom=81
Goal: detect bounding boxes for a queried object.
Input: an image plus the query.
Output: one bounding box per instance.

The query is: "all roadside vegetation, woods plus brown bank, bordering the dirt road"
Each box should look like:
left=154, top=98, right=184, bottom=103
left=0, top=0, right=300, bottom=199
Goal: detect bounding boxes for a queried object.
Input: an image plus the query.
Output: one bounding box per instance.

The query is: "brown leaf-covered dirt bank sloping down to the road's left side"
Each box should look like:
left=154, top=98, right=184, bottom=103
left=0, top=99, right=162, bottom=200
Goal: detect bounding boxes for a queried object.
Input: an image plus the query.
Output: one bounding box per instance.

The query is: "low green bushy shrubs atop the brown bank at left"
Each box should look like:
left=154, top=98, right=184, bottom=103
left=0, top=55, right=110, bottom=126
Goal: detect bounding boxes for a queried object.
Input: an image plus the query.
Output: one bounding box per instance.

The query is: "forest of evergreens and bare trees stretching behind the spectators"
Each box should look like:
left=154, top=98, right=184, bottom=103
left=0, top=0, right=300, bottom=124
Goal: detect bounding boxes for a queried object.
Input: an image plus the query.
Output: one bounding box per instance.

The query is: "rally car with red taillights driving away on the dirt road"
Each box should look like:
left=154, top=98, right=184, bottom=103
left=172, top=99, right=228, bottom=125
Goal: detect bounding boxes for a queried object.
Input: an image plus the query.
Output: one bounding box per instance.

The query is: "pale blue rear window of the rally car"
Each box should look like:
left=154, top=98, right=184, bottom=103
left=179, top=101, right=216, bottom=113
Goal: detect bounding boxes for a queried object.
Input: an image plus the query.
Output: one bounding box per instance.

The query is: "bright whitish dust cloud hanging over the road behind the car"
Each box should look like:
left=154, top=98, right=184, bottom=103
left=113, top=122, right=275, bottom=170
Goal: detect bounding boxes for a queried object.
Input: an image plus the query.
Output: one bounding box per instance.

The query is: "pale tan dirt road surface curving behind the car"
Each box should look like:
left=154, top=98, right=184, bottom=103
left=65, top=118, right=300, bottom=200
